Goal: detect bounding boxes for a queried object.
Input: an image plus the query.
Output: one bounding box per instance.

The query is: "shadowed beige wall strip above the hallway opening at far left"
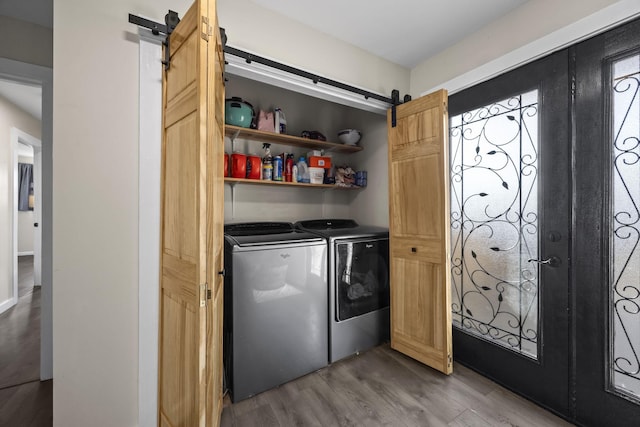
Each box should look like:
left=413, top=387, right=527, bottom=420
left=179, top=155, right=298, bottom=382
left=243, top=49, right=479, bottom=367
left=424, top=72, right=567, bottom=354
left=0, top=15, right=53, bottom=67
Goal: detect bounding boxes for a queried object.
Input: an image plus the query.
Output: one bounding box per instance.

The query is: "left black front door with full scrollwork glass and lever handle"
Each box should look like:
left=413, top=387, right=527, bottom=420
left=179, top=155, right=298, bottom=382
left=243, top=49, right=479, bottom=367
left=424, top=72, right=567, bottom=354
left=449, top=51, right=571, bottom=414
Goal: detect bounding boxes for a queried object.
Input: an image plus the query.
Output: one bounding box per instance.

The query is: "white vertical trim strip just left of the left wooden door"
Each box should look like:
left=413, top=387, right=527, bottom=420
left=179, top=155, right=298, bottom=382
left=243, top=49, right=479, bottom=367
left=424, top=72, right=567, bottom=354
left=138, top=28, right=163, bottom=427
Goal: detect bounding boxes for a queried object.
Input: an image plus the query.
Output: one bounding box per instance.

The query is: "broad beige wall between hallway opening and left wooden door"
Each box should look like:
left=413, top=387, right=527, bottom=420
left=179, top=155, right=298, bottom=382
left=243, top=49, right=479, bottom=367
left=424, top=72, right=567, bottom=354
left=53, top=0, right=190, bottom=427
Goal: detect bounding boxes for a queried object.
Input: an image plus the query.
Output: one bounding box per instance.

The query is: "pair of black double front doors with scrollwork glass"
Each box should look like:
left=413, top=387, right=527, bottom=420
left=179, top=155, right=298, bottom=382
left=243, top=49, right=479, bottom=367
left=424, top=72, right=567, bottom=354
left=449, top=15, right=640, bottom=426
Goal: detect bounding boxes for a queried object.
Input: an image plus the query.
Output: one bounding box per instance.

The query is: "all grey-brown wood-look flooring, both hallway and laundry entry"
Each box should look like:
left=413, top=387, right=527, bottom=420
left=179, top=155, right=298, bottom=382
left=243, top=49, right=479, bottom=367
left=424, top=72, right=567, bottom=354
left=0, top=257, right=571, bottom=427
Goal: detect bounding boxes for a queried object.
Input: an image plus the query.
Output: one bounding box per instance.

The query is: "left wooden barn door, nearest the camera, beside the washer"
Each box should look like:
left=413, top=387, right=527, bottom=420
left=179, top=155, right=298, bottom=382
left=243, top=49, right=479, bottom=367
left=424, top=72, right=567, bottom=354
left=158, top=0, right=224, bottom=426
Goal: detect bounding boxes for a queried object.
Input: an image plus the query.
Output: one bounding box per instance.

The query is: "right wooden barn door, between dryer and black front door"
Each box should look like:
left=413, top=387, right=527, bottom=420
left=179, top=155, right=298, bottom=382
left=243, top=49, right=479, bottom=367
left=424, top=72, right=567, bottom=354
left=388, top=90, right=453, bottom=374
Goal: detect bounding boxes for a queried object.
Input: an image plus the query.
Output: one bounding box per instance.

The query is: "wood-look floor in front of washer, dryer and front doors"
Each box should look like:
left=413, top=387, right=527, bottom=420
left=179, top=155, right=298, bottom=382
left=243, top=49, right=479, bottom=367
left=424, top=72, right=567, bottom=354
left=222, top=345, right=572, bottom=427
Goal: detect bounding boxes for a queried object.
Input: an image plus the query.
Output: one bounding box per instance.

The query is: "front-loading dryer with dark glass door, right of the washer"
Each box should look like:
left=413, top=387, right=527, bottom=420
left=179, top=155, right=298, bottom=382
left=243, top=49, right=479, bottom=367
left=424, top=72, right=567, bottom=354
left=295, top=219, right=390, bottom=363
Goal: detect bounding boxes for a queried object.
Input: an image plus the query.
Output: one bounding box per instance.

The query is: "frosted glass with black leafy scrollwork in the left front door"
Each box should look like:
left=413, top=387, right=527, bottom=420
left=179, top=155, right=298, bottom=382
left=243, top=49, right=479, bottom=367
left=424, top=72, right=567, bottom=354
left=450, top=90, right=539, bottom=358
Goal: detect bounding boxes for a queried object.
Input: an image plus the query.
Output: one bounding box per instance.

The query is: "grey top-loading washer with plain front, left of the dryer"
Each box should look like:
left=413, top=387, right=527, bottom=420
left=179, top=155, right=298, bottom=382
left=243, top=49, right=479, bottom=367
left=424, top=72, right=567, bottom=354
left=224, top=222, right=328, bottom=402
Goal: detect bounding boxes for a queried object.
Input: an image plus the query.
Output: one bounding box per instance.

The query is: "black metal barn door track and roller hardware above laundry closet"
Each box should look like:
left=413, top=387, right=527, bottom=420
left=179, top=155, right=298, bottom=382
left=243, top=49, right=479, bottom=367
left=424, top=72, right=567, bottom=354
left=129, top=10, right=411, bottom=107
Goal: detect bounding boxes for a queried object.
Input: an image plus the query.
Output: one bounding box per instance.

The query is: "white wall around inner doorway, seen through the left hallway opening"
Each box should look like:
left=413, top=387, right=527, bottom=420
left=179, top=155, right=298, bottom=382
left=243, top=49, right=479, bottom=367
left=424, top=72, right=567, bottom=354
left=0, top=97, right=41, bottom=305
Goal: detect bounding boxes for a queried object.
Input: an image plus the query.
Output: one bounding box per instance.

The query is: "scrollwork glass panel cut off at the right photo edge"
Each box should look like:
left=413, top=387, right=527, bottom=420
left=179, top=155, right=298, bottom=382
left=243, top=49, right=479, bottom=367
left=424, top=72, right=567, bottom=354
left=609, top=55, right=640, bottom=398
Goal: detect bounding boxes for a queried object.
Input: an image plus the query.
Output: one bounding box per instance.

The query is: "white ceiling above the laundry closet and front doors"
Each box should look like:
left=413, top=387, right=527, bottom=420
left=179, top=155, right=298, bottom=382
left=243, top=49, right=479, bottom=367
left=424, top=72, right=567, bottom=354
left=252, top=0, right=527, bottom=68
